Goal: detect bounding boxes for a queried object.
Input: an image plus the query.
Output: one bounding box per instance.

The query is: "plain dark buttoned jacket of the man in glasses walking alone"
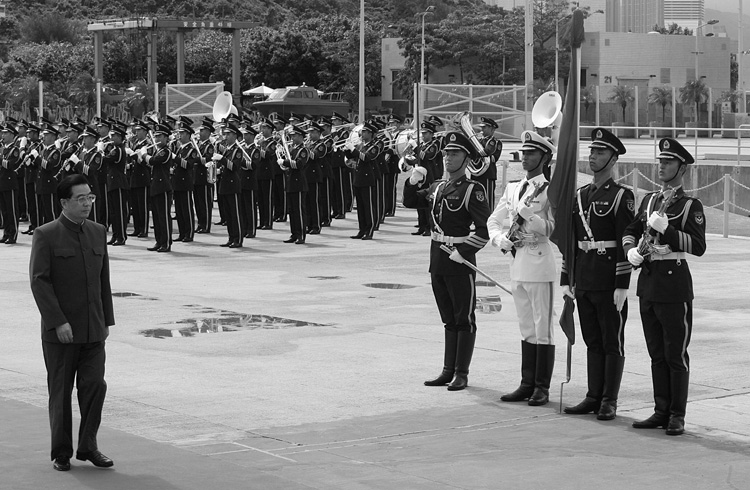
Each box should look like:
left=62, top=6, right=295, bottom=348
left=29, top=214, right=115, bottom=344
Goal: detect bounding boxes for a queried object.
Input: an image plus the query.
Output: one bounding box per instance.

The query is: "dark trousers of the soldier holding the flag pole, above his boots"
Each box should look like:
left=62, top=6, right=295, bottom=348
left=576, top=289, right=628, bottom=357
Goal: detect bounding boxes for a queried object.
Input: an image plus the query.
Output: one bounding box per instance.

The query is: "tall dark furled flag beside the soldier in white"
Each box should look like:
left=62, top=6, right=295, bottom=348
left=547, top=9, right=584, bottom=345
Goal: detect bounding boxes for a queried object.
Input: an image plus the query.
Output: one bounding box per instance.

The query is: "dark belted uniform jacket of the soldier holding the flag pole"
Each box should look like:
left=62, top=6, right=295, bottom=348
left=560, top=179, right=635, bottom=291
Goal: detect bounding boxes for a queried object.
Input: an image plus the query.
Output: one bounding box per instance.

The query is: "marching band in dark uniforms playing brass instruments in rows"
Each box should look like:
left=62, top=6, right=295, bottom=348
left=0, top=112, right=502, bottom=252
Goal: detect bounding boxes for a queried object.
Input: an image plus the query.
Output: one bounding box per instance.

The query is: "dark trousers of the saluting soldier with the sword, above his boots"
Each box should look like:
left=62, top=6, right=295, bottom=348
left=430, top=274, right=477, bottom=333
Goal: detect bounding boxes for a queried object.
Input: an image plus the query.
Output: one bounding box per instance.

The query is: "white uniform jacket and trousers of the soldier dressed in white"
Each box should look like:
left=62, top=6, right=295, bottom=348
left=487, top=175, right=557, bottom=345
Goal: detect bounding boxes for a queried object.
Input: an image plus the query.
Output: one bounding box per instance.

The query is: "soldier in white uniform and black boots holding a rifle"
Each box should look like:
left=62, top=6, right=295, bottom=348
left=487, top=131, right=556, bottom=406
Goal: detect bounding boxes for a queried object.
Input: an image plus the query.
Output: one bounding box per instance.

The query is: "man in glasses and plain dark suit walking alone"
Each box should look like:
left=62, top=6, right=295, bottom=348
left=29, top=175, right=115, bottom=471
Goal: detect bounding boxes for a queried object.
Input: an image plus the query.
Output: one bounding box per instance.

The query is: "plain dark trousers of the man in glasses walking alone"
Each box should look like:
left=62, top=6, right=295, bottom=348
left=42, top=342, right=107, bottom=459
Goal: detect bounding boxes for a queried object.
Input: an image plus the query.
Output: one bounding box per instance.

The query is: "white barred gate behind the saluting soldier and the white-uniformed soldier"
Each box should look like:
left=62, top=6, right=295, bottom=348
left=419, top=84, right=533, bottom=140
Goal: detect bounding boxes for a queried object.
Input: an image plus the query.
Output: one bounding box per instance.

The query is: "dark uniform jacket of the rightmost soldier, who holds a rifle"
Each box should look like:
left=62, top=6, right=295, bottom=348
left=622, top=187, right=706, bottom=303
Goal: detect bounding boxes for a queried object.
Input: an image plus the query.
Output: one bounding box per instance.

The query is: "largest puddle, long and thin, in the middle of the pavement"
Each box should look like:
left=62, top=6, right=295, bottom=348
left=140, top=308, right=332, bottom=339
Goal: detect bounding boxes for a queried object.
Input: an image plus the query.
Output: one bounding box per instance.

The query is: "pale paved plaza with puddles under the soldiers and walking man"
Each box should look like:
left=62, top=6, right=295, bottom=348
left=0, top=181, right=750, bottom=490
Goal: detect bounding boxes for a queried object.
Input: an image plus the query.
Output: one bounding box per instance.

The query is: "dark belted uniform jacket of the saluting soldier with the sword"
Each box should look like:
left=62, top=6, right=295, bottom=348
left=404, top=177, right=490, bottom=276
